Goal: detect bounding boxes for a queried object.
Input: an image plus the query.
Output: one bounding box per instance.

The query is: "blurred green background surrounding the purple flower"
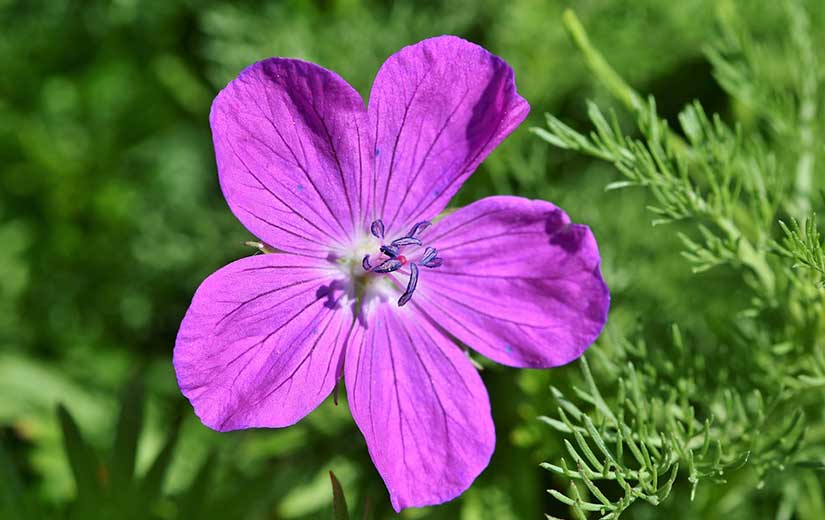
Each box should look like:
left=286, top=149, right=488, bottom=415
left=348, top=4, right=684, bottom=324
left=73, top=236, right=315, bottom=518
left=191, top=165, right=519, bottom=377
left=0, top=0, right=812, bottom=520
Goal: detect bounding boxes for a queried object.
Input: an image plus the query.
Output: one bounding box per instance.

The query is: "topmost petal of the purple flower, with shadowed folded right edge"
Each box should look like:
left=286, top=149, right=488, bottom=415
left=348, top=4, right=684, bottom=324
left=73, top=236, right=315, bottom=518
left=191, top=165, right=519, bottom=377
left=369, top=36, right=530, bottom=236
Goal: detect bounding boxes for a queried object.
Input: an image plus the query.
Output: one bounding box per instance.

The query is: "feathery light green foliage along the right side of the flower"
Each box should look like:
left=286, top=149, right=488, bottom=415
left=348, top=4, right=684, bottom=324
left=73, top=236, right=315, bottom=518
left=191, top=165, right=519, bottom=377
left=533, top=2, right=825, bottom=519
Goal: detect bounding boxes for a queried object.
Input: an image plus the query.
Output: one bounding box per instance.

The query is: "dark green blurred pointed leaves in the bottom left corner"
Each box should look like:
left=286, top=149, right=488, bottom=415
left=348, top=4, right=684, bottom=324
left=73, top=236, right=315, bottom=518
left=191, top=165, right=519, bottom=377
left=0, top=380, right=332, bottom=520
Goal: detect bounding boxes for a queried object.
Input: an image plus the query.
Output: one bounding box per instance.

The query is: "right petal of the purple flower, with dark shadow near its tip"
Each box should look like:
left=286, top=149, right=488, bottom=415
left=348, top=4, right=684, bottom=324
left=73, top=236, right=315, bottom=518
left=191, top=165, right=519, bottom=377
left=412, top=197, right=610, bottom=368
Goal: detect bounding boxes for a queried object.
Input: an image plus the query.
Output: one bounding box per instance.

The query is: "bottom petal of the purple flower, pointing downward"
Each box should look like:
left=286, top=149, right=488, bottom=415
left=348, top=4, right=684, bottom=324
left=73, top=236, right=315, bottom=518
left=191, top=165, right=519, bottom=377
left=345, top=304, right=495, bottom=511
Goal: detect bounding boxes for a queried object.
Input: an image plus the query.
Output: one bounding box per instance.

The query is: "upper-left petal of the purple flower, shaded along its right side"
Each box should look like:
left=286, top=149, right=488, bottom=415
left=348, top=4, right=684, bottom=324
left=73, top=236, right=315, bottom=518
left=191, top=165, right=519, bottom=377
left=210, top=58, right=372, bottom=256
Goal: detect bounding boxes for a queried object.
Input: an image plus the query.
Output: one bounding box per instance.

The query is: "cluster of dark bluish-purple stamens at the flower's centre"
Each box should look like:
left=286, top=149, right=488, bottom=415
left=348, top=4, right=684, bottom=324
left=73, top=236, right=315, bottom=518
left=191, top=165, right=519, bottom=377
left=361, top=219, right=443, bottom=307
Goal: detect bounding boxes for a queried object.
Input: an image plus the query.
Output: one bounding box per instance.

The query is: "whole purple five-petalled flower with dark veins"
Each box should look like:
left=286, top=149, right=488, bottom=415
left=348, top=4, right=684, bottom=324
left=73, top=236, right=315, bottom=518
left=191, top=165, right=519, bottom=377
left=174, top=36, right=609, bottom=511
